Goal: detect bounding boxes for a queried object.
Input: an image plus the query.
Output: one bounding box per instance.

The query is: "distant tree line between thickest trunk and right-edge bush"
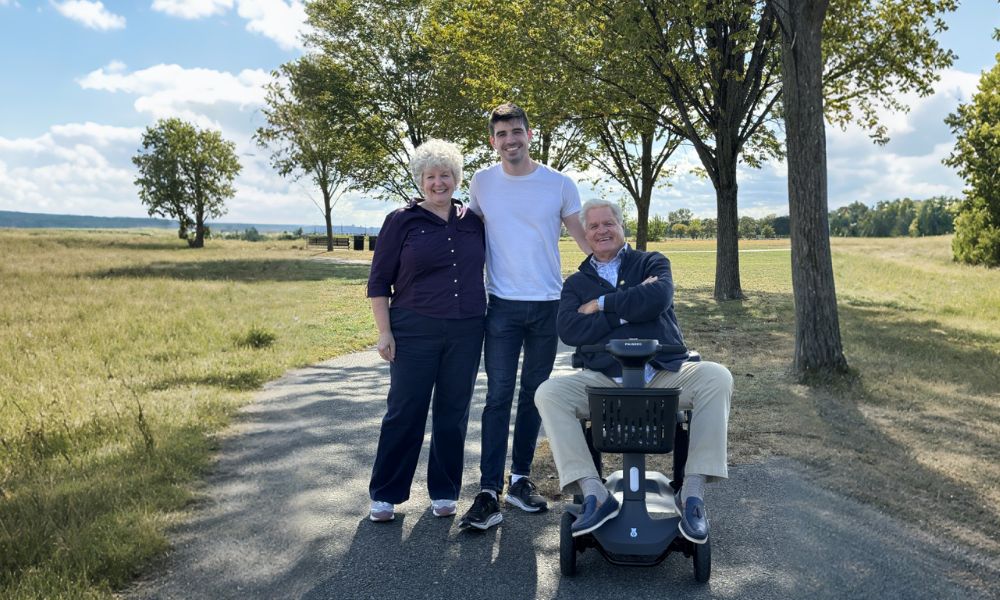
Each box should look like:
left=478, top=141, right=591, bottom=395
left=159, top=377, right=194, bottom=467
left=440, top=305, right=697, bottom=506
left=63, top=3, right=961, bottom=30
left=830, top=196, right=958, bottom=237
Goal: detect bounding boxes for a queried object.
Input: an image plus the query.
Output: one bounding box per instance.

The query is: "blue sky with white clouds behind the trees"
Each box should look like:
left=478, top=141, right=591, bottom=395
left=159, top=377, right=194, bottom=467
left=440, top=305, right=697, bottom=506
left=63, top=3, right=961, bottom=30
left=0, top=0, right=1000, bottom=226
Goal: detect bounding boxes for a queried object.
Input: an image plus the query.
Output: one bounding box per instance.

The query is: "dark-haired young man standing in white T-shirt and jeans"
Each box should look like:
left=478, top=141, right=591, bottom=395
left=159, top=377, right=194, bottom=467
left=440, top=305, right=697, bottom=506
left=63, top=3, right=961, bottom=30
left=459, top=104, right=589, bottom=529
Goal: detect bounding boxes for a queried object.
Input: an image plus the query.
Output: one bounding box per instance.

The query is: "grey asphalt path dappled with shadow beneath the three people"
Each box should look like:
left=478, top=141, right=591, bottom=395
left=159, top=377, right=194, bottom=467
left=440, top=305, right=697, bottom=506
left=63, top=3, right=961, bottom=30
left=124, top=348, right=1000, bottom=600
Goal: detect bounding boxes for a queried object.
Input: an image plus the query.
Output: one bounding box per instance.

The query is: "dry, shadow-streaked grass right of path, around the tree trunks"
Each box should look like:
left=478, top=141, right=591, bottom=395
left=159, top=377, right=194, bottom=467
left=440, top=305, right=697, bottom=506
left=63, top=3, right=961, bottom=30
left=536, top=237, right=1000, bottom=559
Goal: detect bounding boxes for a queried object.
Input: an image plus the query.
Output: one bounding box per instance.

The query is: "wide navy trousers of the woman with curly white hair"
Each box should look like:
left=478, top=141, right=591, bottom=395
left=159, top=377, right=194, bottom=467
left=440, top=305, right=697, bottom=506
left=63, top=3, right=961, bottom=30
left=368, top=309, right=485, bottom=504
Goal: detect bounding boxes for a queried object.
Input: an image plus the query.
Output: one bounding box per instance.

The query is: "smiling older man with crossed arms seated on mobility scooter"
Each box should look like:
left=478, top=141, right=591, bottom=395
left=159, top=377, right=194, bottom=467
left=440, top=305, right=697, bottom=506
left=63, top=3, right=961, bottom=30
left=535, top=200, right=733, bottom=544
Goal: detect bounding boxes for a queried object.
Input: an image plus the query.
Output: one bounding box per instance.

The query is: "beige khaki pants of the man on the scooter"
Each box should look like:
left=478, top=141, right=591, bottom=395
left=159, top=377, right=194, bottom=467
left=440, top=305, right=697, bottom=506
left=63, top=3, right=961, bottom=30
left=535, top=361, right=733, bottom=493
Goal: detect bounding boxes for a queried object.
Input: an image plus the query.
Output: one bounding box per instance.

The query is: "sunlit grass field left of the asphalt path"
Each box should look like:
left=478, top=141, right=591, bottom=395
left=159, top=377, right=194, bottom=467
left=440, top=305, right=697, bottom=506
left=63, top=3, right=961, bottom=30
left=0, top=230, right=375, bottom=598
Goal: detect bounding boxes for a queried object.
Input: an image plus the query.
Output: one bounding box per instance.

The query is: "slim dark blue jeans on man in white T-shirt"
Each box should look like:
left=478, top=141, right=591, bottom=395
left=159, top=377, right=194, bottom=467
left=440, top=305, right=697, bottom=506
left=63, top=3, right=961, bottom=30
left=479, top=295, right=559, bottom=493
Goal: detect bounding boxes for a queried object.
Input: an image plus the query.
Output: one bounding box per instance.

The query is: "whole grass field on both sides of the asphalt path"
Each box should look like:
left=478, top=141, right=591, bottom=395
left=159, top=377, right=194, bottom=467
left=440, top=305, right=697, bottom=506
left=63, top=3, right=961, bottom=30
left=0, top=230, right=1000, bottom=598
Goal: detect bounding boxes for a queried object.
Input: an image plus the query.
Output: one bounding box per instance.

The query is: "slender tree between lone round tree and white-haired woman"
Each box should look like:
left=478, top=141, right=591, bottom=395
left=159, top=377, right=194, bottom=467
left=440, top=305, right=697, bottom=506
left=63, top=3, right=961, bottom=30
left=254, top=54, right=362, bottom=251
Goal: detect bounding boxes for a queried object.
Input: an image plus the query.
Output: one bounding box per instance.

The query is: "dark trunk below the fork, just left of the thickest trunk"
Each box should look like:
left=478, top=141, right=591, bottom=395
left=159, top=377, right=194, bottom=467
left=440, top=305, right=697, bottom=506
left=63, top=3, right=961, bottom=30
left=715, top=152, right=744, bottom=301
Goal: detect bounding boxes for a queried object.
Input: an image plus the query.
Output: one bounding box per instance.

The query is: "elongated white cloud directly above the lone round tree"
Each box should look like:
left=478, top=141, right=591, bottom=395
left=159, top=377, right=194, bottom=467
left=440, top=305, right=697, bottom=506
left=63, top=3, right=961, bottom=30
left=79, top=61, right=270, bottom=123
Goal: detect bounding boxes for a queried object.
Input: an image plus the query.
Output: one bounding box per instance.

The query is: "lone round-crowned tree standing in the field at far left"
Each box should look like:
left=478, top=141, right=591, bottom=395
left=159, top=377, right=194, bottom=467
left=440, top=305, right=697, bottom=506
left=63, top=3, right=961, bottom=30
left=132, top=119, right=241, bottom=248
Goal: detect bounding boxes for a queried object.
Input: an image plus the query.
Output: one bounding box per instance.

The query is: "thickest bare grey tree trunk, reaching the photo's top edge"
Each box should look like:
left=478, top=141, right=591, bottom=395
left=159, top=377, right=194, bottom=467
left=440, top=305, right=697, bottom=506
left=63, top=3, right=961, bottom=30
left=775, top=0, right=847, bottom=375
